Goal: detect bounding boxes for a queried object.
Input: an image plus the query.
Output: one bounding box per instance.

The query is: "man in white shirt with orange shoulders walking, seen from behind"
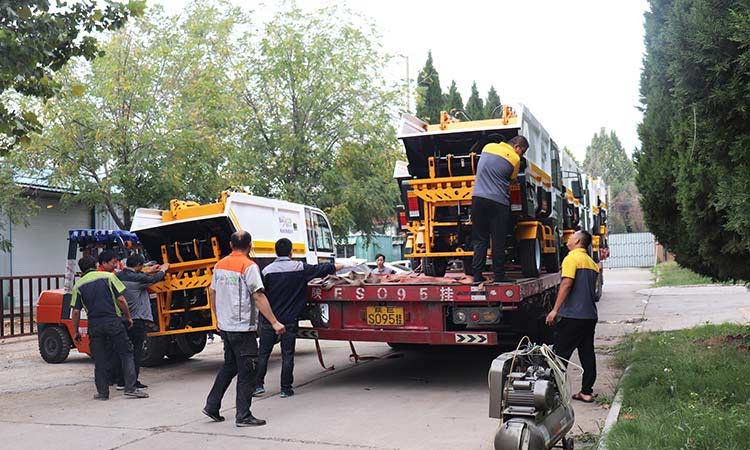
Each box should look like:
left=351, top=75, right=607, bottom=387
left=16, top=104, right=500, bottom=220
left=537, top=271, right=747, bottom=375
left=203, top=231, right=286, bottom=427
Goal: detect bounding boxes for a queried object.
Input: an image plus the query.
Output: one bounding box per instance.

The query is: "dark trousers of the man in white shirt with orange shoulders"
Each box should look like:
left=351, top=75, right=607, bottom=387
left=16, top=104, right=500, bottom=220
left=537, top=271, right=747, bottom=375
left=206, top=331, right=258, bottom=421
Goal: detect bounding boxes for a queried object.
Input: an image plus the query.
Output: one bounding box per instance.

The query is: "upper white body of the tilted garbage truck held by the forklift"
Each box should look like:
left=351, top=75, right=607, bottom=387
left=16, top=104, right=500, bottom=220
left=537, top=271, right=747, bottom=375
left=130, top=192, right=336, bottom=266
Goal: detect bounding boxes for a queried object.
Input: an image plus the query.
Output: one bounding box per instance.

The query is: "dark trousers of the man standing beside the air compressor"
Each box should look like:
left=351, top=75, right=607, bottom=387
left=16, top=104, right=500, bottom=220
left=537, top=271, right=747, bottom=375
left=555, top=317, right=596, bottom=395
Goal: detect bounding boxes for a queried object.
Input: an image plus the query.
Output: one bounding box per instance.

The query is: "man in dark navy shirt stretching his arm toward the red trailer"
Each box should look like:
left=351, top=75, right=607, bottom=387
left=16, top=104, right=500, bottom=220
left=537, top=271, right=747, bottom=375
left=253, top=238, right=344, bottom=398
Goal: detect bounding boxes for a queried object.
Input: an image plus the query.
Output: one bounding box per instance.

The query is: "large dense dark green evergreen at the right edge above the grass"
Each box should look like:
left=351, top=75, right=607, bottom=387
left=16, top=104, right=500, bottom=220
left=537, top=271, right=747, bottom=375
left=635, top=0, right=750, bottom=280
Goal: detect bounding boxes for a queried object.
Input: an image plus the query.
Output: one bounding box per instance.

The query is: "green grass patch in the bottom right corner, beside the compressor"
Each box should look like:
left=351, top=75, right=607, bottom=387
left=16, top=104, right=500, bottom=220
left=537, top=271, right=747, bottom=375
left=607, top=324, right=750, bottom=450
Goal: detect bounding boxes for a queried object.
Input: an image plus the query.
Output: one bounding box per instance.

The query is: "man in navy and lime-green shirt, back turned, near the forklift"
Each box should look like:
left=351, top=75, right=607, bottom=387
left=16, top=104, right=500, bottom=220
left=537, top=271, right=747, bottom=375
left=70, top=256, right=148, bottom=400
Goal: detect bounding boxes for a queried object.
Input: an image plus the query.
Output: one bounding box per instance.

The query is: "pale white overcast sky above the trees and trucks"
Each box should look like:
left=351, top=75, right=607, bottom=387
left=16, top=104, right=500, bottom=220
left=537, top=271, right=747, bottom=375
left=156, top=0, right=647, bottom=160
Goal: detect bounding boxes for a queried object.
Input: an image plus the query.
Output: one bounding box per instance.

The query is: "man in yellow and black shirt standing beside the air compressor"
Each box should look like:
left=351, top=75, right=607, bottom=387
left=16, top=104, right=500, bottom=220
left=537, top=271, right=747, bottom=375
left=546, top=230, right=599, bottom=403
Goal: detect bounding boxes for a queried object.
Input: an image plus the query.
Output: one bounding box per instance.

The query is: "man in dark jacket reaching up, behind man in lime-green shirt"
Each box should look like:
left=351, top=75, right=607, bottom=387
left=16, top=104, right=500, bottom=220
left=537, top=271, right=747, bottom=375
left=111, top=254, right=169, bottom=390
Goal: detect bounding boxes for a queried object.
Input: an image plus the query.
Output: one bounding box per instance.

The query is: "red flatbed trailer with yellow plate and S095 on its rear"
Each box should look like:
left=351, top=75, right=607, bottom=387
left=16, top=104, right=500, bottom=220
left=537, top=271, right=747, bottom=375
left=299, top=273, right=560, bottom=347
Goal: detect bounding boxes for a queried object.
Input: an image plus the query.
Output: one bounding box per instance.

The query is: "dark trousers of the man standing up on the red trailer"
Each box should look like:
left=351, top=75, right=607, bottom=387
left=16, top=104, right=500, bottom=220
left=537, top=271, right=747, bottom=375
left=471, top=197, right=510, bottom=281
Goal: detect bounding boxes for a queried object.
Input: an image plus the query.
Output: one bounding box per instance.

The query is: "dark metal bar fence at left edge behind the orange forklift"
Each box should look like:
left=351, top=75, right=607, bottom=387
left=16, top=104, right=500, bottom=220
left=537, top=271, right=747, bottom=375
left=0, top=275, right=64, bottom=338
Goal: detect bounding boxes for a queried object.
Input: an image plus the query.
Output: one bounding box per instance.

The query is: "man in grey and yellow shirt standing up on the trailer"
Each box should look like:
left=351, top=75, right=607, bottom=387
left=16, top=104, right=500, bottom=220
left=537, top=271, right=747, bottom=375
left=471, top=135, right=529, bottom=283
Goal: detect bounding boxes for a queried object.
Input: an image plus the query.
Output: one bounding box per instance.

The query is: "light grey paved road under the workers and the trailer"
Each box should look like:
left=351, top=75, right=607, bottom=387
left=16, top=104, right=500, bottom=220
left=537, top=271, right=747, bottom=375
left=0, top=270, right=750, bottom=450
